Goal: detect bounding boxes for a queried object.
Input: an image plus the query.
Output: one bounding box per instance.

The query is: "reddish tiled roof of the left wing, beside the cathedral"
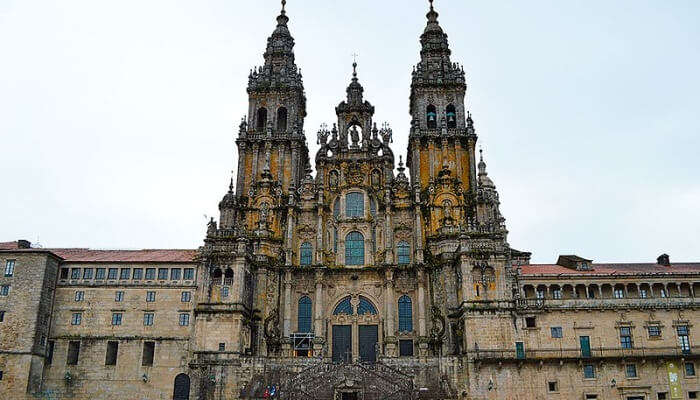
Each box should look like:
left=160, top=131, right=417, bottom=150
left=48, top=249, right=197, bottom=263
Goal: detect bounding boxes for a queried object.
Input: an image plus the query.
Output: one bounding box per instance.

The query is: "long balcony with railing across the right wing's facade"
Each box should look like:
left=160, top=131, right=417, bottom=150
left=469, top=346, right=700, bottom=362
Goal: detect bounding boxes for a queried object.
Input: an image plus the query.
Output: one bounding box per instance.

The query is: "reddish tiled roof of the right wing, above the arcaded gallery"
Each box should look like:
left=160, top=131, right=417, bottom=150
left=521, top=263, right=700, bottom=275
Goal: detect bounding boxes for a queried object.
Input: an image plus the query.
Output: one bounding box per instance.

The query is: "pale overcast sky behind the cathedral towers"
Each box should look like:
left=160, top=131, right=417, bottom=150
left=0, top=0, right=700, bottom=262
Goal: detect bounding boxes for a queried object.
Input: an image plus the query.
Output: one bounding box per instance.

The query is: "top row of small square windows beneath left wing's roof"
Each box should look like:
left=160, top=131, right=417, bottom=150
left=61, top=268, right=194, bottom=281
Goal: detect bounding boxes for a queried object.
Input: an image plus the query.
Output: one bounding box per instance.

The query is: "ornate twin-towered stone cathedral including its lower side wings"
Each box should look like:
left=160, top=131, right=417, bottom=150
left=0, top=0, right=700, bottom=400
